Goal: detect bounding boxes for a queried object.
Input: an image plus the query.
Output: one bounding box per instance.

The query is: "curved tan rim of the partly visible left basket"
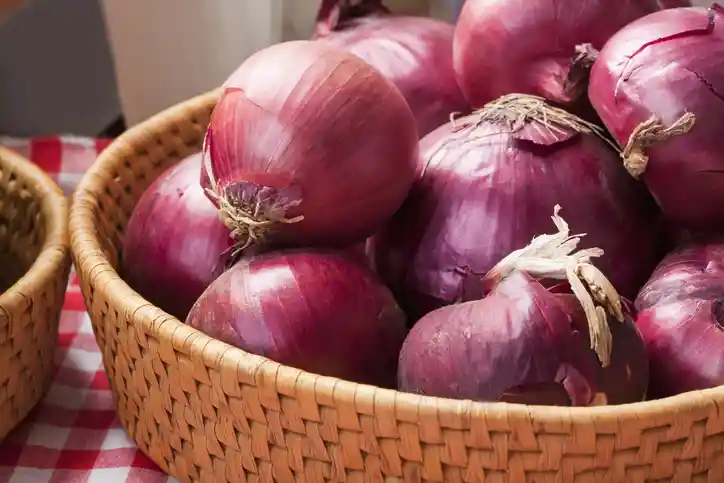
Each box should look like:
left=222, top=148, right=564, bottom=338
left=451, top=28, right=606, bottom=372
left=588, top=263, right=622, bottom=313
left=0, top=147, right=69, bottom=313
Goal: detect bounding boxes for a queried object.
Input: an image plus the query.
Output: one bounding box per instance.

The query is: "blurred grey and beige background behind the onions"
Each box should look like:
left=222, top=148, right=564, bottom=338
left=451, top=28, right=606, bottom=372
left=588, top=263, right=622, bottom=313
left=0, top=0, right=463, bottom=137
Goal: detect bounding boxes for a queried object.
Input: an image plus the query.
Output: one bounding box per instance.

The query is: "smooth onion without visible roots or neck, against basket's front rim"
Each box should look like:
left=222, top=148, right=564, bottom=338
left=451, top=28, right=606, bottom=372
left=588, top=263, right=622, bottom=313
left=186, top=250, right=406, bottom=387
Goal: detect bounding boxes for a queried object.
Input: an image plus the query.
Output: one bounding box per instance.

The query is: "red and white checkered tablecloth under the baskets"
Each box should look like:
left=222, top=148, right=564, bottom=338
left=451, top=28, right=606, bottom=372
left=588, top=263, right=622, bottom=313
left=0, top=136, right=176, bottom=483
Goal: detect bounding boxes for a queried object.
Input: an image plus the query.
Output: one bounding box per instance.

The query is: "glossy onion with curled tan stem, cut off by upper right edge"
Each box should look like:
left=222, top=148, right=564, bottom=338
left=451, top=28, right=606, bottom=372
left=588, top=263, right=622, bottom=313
left=589, top=4, right=724, bottom=229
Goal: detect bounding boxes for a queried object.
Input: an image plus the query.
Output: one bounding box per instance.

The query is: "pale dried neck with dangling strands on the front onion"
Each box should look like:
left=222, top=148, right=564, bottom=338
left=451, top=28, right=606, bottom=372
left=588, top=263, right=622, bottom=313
left=483, top=205, right=624, bottom=367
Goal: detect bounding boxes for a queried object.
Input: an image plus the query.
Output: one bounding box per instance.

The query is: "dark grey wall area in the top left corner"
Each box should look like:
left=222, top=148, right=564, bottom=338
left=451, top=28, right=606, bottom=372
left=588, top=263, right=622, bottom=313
left=0, top=0, right=120, bottom=136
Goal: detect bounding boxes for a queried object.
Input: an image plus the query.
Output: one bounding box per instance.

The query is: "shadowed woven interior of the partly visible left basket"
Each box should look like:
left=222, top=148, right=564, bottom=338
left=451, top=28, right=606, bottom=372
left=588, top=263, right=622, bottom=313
left=0, top=153, right=47, bottom=293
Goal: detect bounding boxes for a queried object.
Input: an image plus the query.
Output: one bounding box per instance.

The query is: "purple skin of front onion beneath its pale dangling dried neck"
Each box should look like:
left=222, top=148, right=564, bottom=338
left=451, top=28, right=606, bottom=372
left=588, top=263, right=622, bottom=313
left=398, top=272, right=648, bottom=406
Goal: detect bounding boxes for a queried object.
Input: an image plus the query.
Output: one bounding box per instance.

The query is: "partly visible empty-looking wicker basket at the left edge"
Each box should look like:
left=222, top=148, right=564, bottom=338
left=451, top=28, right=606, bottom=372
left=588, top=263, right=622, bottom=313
left=0, top=148, right=70, bottom=439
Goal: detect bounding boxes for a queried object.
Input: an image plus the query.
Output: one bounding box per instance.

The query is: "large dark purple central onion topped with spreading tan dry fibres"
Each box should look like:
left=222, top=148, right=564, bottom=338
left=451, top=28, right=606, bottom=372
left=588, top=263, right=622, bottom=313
left=376, top=95, right=659, bottom=319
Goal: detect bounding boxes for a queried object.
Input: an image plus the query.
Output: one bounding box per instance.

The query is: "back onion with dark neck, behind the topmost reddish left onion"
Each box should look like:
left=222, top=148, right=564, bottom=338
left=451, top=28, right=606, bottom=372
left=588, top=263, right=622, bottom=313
left=314, top=0, right=470, bottom=137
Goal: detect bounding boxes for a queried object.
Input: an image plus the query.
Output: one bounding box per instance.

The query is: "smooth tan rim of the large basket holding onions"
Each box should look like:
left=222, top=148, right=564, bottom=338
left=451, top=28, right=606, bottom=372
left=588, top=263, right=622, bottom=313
left=70, top=89, right=724, bottom=424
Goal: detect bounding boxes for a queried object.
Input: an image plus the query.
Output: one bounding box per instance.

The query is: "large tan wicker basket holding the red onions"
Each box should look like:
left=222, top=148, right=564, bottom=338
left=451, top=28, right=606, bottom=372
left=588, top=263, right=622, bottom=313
left=70, top=93, right=724, bottom=483
